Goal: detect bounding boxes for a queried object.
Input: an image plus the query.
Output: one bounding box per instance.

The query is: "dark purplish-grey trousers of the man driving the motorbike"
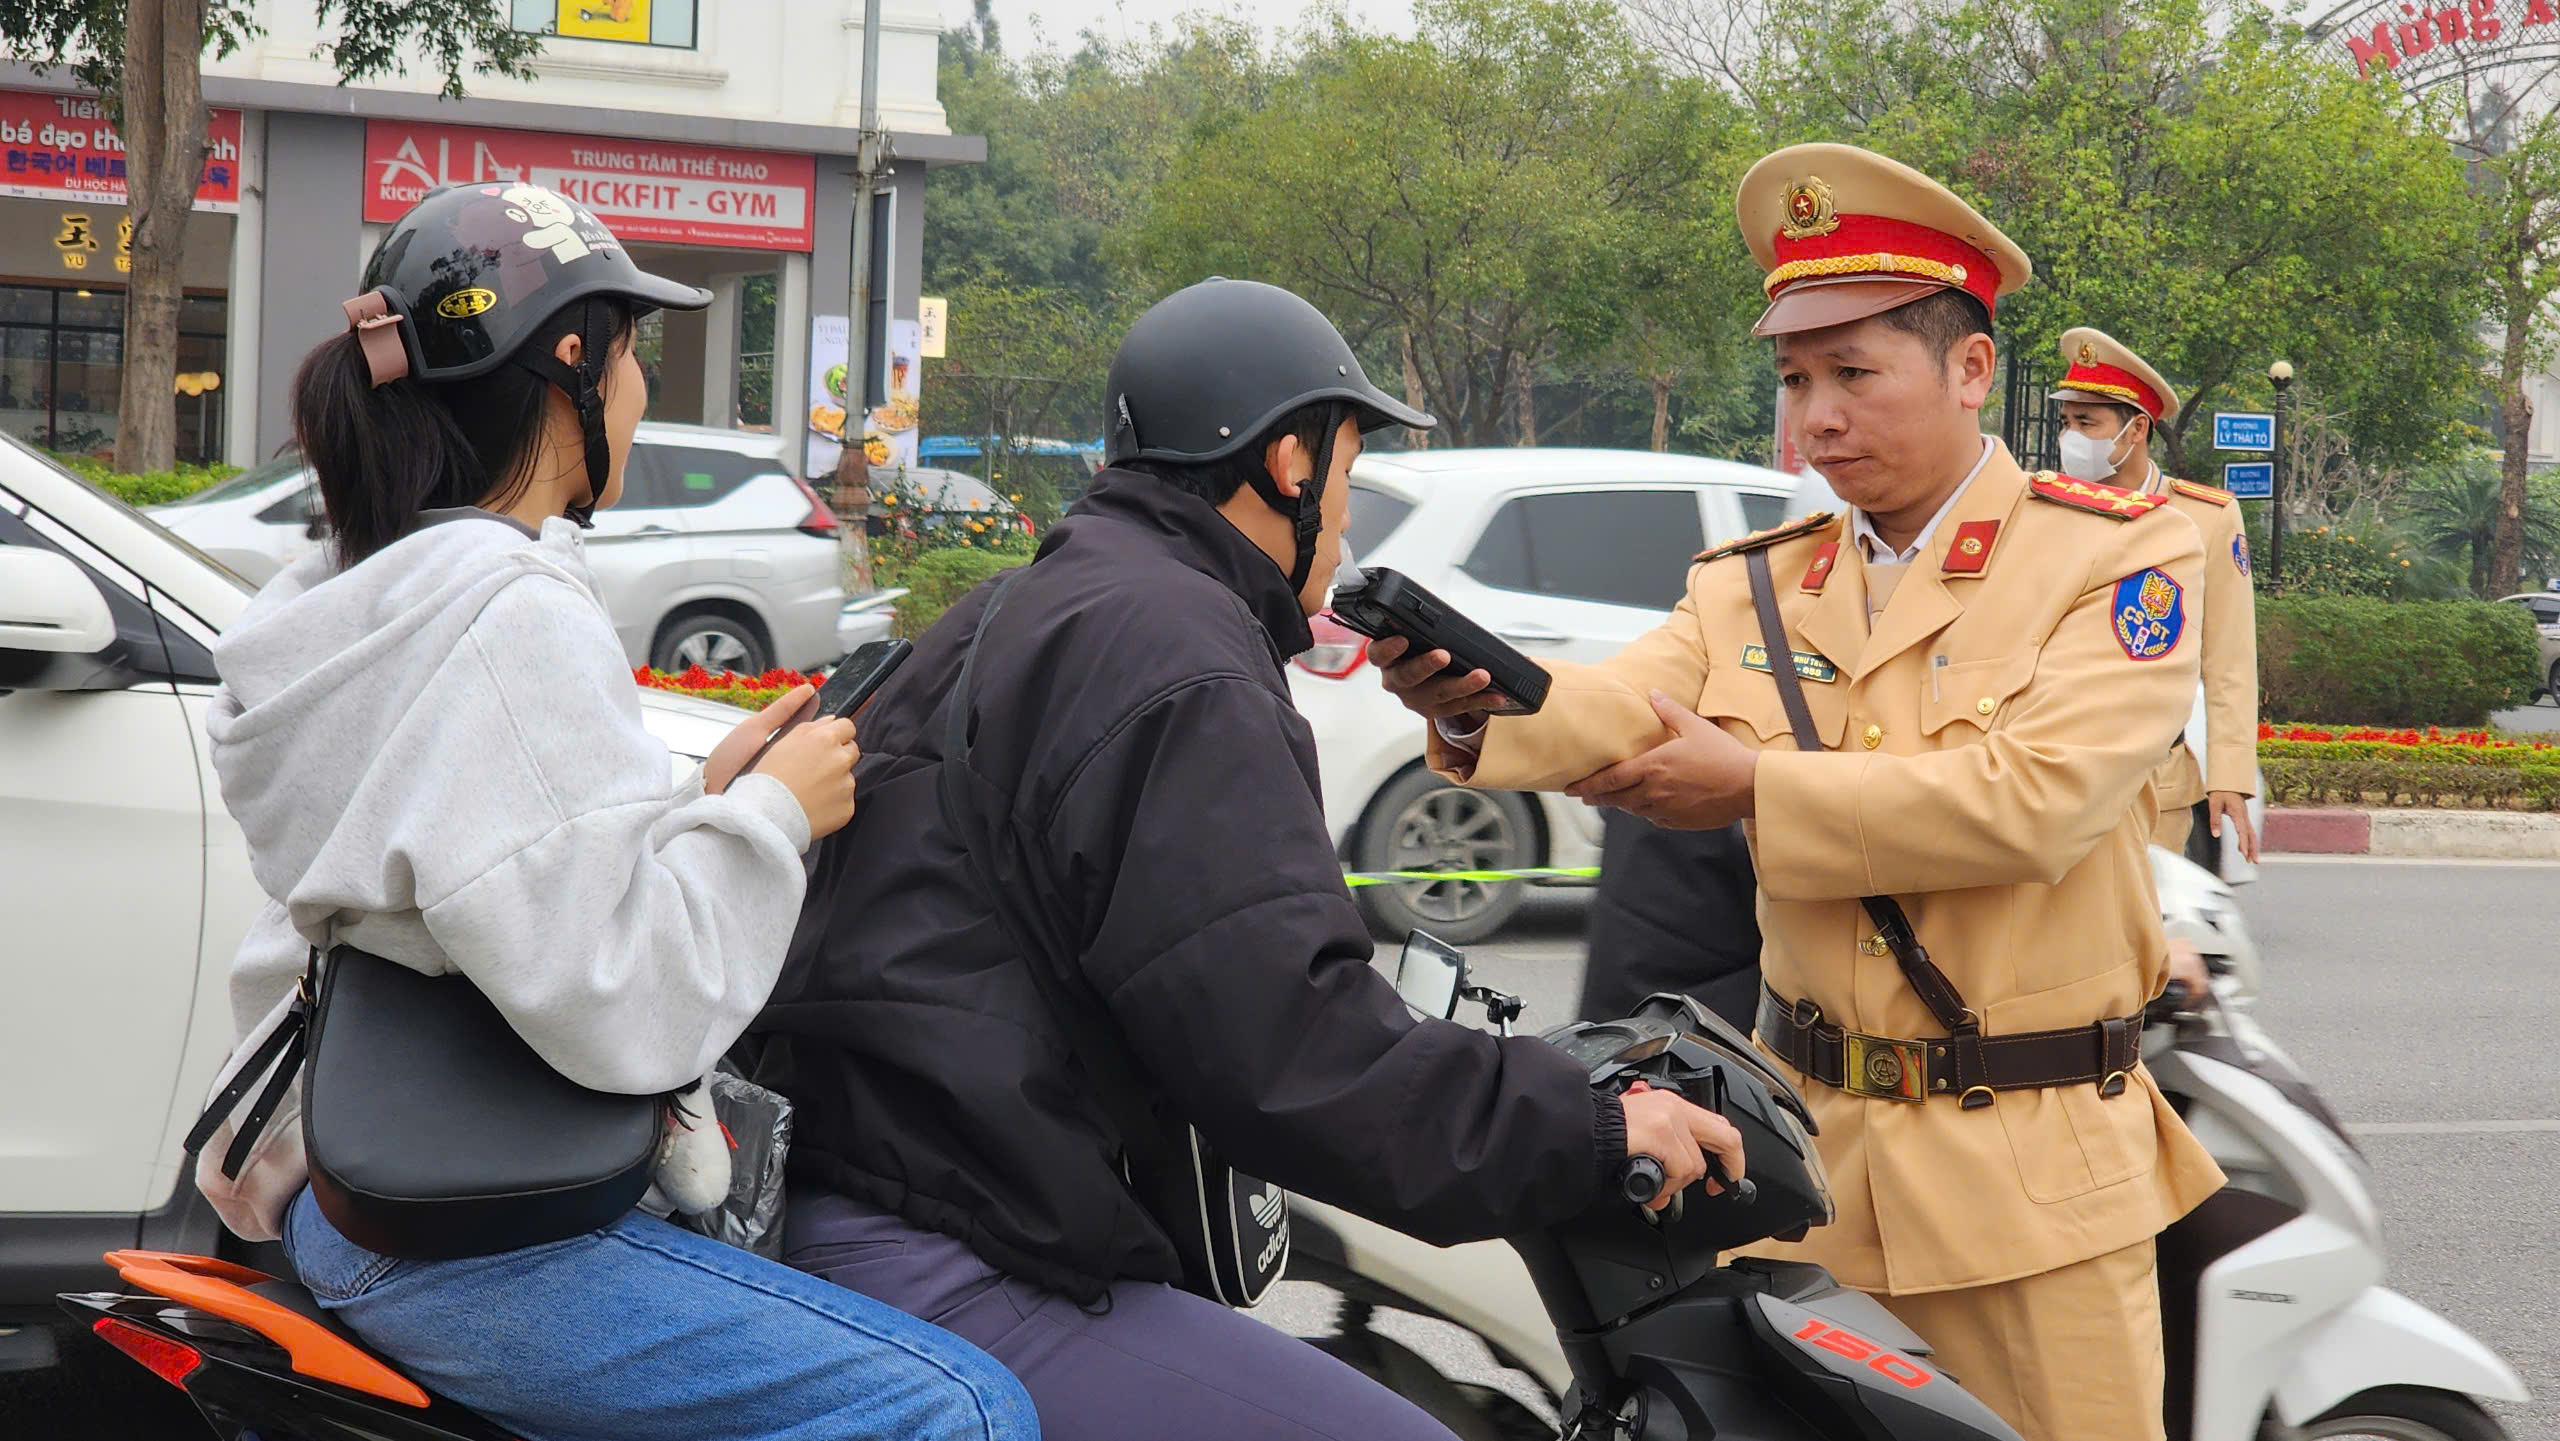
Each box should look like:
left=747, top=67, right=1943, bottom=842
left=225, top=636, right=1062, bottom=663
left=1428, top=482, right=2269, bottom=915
left=783, top=1190, right=1454, bottom=1441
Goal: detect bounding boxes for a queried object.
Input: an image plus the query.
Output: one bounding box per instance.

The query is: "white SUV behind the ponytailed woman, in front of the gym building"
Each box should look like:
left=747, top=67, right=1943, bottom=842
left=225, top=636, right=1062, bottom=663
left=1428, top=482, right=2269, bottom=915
left=151, top=422, right=845, bottom=676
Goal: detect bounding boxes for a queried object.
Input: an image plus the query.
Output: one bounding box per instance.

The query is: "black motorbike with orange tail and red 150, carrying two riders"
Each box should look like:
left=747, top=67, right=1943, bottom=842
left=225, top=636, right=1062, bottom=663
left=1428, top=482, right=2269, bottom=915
left=61, top=937, right=2020, bottom=1441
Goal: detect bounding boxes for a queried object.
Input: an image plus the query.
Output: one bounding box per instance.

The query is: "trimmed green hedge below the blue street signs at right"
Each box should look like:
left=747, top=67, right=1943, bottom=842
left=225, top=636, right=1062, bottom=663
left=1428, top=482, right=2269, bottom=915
left=2258, top=596, right=2542, bottom=727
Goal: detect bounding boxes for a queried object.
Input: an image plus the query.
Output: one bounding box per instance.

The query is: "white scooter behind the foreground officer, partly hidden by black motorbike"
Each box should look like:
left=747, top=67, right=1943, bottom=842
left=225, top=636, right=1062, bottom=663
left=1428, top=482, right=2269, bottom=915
left=1290, top=850, right=2527, bottom=1441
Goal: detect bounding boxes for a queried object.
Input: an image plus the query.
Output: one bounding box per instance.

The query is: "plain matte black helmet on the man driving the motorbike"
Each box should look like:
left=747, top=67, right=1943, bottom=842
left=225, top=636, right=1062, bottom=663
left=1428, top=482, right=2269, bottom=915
left=1103, top=276, right=1439, bottom=589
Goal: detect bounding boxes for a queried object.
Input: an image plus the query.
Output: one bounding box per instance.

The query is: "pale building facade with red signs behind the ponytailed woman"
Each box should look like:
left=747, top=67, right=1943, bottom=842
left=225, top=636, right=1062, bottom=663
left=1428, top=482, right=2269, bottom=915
left=0, top=0, right=986, bottom=466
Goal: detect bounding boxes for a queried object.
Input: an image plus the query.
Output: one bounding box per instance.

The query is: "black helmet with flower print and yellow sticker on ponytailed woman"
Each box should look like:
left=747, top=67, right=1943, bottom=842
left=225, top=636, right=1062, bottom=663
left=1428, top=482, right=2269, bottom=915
left=346, top=182, right=712, bottom=525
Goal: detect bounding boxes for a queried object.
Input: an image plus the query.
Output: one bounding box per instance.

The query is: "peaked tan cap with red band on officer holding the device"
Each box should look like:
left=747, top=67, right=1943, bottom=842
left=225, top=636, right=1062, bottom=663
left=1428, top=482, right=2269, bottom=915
left=1733, top=143, right=2035, bottom=335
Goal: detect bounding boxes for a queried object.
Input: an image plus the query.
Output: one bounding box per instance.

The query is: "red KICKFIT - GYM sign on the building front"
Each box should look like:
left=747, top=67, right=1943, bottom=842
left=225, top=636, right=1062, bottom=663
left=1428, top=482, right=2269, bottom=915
left=364, top=120, right=817, bottom=251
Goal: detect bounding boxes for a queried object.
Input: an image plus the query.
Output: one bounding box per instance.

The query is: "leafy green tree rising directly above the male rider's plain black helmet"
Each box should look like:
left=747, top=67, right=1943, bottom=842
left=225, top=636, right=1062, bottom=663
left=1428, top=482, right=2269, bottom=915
left=1132, top=0, right=1748, bottom=445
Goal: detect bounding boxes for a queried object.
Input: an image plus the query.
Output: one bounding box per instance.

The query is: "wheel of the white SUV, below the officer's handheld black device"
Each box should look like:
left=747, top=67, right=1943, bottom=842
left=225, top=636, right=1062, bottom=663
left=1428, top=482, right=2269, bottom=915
left=1352, top=768, right=1539, bottom=944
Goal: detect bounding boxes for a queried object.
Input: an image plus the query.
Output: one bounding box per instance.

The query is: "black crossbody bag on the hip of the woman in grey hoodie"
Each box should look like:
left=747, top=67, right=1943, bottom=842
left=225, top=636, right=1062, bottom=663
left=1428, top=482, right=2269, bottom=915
left=187, top=944, right=666, bottom=1259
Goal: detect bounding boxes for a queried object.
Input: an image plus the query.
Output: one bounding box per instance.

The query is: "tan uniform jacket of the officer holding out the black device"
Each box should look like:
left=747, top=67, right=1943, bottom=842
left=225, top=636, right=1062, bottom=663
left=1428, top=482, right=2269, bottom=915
left=1431, top=450, right=2222, bottom=1293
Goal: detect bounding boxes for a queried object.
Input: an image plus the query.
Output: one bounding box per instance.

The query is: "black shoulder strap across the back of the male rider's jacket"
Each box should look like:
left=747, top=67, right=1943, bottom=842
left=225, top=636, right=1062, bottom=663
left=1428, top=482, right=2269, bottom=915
left=940, top=571, right=1175, bottom=1167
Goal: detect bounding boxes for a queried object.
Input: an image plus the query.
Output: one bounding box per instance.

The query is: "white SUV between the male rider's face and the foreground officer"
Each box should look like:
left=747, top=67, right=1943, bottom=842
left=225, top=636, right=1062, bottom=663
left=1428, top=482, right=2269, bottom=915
left=1290, top=450, right=1795, bottom=944
